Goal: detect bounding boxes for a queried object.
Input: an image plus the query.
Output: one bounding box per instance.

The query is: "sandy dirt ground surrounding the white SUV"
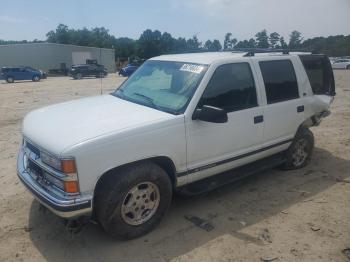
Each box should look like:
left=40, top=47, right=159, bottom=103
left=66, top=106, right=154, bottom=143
left=0, top=71, right=350, bottom=262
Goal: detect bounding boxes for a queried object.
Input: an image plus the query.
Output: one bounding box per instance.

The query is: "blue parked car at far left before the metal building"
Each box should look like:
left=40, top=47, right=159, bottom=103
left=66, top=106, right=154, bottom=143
left=1, top=66, right=46, bottom=83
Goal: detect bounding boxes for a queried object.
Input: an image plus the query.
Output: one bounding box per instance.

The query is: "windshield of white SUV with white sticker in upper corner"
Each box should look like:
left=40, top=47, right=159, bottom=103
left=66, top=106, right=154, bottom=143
left=112, top=60, right=207, bottom=114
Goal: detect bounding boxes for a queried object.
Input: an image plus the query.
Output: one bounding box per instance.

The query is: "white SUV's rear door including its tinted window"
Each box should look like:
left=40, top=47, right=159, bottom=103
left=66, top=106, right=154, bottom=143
left=255, top=57, right=305, bottom=150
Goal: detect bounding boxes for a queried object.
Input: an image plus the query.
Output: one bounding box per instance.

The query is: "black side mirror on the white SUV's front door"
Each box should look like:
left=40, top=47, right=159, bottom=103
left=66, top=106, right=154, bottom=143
left=192, top=105, right=227, bottom=123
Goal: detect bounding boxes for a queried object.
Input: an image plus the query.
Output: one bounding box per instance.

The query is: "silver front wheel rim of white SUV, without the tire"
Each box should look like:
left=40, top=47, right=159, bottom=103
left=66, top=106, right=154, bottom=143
left=121, top=182, right=160, bottom=226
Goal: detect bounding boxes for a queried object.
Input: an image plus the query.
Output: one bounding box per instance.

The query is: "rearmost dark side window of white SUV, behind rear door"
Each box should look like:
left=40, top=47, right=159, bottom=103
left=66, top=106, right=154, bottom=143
left=300, top=55, right=335, bottom=96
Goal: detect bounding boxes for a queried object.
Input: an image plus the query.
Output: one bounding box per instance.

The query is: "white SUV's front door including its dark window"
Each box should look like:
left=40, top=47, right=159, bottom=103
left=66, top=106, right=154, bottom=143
left=186, top=62, right=264, bottom=182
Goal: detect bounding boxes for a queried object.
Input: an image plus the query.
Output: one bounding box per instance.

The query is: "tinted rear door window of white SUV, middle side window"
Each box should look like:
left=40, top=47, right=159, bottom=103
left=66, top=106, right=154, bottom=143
left=259, top=60, right=299, bottom=104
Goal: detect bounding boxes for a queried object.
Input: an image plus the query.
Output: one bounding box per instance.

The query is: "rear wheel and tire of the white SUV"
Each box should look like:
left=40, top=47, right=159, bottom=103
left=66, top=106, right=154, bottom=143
left=282, top=128, right=314, bottom=170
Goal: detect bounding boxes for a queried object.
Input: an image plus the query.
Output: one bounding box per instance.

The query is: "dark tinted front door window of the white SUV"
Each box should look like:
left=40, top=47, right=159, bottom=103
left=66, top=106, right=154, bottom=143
left=199, top=63, right=258, bottom=112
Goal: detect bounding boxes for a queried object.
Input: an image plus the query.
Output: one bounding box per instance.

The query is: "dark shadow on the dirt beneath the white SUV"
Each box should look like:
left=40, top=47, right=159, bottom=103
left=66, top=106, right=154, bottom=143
left=28, top=148, right=350, bottom=261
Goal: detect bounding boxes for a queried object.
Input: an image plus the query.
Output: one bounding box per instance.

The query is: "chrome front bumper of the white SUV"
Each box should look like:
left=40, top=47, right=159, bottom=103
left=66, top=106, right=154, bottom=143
left=17, top=148, right=92, bottom=218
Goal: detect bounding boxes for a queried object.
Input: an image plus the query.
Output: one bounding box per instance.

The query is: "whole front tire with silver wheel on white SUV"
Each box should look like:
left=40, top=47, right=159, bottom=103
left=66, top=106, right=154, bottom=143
left=95, top=162, right=172, bottom=239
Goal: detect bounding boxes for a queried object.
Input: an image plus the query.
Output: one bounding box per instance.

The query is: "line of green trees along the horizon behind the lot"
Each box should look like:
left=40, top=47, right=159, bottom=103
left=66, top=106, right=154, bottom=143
left=0, top=24, right=350, bottom=61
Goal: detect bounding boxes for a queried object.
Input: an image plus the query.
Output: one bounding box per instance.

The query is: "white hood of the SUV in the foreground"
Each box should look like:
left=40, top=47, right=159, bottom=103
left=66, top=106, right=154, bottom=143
left=23, top=95, right=173, bottom=155
